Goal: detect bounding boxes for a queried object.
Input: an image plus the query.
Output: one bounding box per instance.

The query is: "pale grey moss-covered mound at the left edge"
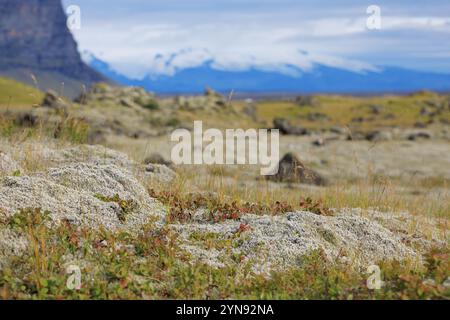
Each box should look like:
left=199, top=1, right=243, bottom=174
left=0, top=146, right=170, bottom=230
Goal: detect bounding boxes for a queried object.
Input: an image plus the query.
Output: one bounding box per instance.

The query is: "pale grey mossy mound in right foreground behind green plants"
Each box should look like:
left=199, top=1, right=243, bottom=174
left=173, top=210, right=428, bottom=274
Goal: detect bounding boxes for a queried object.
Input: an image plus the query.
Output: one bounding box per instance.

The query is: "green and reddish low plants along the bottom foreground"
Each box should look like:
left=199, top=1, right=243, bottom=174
left=0, top=209, right=450, bottom=299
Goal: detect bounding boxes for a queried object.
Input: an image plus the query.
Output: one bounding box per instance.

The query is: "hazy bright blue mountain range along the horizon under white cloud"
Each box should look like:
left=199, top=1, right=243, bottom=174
left=88, top=55, right=450, bottom=94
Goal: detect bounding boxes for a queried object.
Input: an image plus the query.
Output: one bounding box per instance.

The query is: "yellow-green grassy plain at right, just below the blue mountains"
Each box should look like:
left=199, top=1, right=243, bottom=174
left=256, top=91, right=450, bottom=131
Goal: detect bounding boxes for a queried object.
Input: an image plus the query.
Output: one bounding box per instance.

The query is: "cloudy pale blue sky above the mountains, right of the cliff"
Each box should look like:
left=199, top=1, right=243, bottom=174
left=63, top=0, right=450, bottom=79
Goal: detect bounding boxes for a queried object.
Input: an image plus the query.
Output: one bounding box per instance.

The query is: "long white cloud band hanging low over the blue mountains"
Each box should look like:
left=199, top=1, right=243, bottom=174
left=71, top=14, right=450, bottom=79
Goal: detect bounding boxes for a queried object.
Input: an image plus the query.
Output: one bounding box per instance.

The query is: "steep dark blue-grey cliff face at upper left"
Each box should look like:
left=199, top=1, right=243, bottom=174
left=0, top=0, right=105, bottom=97
